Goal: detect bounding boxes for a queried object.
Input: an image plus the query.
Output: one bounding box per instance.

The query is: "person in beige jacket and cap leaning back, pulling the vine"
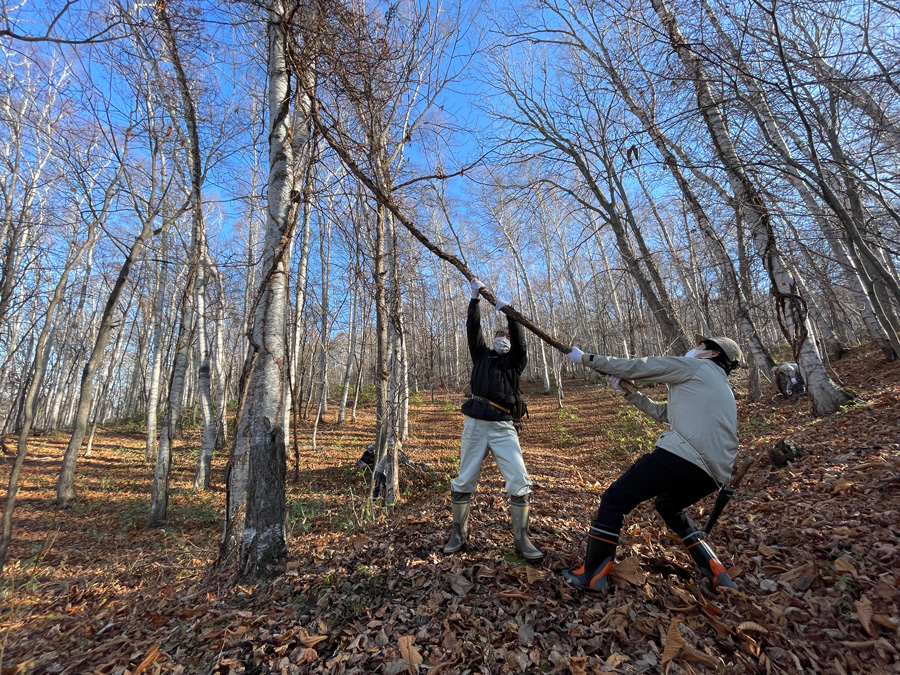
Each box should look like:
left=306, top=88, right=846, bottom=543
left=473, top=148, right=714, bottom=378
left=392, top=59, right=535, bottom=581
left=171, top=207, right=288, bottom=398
left=563, top=335, right=741, bottom=591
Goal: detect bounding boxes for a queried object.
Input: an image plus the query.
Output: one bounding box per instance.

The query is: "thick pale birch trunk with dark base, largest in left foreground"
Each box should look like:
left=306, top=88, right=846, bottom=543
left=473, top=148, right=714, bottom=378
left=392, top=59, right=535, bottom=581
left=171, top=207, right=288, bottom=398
left=219, top=0, right=307, bottom=578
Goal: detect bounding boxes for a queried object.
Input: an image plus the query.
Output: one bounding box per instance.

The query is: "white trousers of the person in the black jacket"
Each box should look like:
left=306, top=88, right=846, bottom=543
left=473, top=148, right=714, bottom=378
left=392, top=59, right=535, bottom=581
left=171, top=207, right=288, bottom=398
left=450, top=415, right=532, bottom=497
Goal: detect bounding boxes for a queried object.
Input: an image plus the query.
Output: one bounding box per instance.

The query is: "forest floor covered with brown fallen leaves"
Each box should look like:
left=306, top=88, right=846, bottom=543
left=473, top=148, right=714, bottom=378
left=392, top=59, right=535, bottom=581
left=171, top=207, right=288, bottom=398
left=0, top=347, right=900, bottom=675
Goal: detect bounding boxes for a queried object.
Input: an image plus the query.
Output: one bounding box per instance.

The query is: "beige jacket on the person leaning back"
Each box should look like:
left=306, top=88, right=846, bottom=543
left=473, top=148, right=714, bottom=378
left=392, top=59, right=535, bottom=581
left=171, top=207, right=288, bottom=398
left=582, top=354, right=738, bottom=484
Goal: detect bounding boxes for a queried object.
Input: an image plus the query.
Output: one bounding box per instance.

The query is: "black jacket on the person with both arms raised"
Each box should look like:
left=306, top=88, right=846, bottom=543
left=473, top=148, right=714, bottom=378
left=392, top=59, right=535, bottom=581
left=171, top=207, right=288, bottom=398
left=462, top=300, right=528, bottom=421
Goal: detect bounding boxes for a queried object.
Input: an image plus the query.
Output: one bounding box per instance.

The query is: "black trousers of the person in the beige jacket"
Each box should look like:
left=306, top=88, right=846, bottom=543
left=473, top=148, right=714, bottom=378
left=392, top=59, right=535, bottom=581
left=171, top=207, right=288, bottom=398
left=594, top=448, right=718, bottom=534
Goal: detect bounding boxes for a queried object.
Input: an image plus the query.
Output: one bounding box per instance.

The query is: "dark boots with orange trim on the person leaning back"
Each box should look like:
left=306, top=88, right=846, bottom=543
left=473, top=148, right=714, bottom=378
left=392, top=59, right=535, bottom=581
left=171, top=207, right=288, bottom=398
left=563, top=521, right=737, bottom=591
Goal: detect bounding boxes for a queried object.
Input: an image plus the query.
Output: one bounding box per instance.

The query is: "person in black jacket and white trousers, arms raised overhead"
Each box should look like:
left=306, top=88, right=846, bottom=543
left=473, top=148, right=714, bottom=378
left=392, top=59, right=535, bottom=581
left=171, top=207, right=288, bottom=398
left=444, top=279, right=544, bottom=562
